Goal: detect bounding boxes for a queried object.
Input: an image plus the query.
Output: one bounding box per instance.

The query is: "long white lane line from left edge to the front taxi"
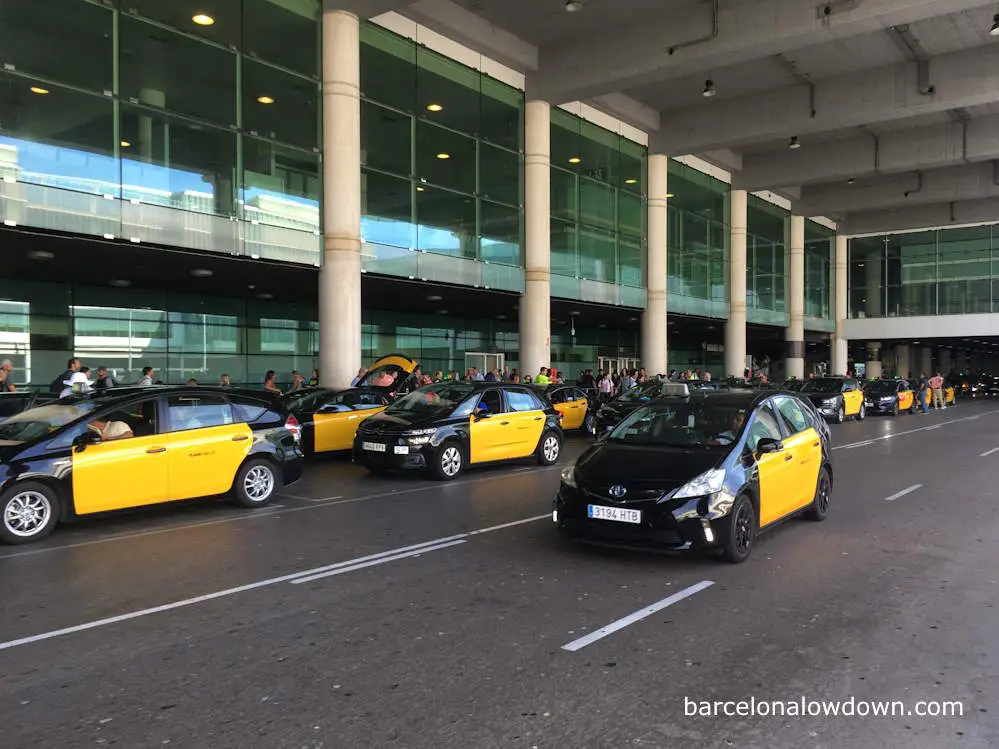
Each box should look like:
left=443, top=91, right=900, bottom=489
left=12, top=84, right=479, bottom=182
left=0, top=516, right=550, bottom=651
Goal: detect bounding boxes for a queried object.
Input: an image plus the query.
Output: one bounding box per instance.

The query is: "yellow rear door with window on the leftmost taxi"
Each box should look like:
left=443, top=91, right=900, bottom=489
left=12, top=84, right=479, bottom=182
left=166, top=393, right=253, bottom=500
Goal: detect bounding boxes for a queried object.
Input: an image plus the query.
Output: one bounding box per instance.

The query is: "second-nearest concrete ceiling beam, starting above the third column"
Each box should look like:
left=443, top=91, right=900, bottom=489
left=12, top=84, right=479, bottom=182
left=660, top=44, right=999, bottom=154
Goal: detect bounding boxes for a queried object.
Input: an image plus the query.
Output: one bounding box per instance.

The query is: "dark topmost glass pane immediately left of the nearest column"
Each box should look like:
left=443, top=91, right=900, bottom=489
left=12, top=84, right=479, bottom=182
left=244, top=0, right=320, bottom=77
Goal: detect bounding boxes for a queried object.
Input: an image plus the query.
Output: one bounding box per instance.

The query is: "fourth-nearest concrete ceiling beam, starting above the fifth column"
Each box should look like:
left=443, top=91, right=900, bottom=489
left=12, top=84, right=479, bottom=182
left=801, top=161, right=999, bottom=213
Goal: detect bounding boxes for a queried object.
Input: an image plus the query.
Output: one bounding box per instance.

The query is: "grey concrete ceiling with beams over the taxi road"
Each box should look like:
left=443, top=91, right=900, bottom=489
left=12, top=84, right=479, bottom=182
left=374, top=0, right=999, bottom=231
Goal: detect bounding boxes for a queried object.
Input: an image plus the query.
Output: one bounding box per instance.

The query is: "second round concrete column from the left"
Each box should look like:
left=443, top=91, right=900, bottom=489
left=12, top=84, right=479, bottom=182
left=520, top=101, right=552, bottom=377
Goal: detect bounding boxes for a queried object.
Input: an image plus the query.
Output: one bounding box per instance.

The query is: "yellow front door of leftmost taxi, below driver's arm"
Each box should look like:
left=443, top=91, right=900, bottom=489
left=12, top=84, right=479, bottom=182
left=72, top=399, right=168, bottom=515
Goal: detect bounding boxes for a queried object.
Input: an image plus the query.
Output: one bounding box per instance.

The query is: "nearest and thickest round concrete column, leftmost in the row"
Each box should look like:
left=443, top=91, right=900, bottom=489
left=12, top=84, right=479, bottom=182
left=319, top=10, right=361, bottom=387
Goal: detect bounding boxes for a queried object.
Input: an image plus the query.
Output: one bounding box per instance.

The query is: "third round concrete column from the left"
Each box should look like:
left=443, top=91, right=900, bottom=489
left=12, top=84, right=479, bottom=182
left=642, top=153, right=669, bottom=376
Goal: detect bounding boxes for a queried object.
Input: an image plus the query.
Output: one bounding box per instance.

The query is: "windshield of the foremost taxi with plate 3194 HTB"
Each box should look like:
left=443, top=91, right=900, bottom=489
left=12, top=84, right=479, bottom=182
left=607, top=400, right=748, bottom=448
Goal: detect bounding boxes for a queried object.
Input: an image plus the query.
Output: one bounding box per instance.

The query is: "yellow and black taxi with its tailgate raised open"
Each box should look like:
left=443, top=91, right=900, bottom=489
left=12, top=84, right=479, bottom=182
left=282, top=354, right=419, bottom=456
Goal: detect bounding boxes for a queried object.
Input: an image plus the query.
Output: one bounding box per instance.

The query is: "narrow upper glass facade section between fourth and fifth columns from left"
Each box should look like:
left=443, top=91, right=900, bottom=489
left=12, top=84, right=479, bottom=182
left=746, top=195, right=791, bottom=326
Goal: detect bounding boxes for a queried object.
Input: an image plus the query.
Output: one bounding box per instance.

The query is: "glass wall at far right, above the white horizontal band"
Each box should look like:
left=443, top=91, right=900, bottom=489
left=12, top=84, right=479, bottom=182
left=849, top=224, right=999, bottom=317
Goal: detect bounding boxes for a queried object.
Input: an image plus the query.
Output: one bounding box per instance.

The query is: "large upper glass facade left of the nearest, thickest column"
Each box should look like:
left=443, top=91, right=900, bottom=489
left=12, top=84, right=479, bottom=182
left=0, top=0, right=321, bottom=265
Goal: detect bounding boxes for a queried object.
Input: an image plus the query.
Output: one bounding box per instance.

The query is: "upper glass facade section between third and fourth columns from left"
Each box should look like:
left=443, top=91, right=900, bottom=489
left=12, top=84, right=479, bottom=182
left=666, top=159, right=731, bottom=318
